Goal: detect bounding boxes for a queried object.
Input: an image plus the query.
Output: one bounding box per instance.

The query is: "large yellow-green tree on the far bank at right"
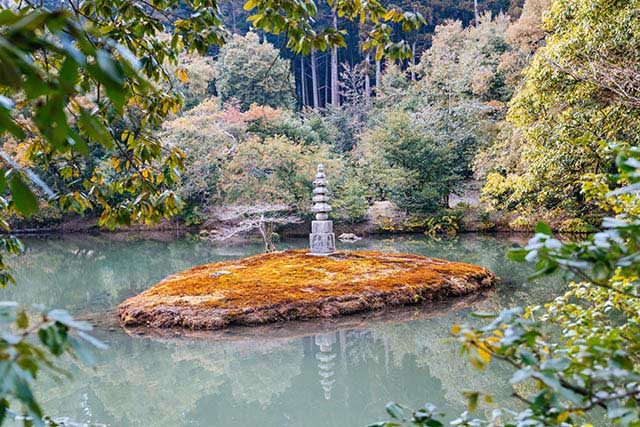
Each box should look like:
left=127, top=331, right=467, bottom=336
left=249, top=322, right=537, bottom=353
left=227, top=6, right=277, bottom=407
left=484, top=1, right=640, bottom=224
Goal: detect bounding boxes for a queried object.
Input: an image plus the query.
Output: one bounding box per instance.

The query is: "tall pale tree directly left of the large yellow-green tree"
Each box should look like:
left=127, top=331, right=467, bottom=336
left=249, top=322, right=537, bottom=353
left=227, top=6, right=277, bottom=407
left=372, top=15, right=509, bottom=205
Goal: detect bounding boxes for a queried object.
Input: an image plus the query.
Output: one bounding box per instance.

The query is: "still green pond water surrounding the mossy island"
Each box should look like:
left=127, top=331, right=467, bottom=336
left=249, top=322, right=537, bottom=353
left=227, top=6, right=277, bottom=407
left=1, top=234, right=561, bottom=427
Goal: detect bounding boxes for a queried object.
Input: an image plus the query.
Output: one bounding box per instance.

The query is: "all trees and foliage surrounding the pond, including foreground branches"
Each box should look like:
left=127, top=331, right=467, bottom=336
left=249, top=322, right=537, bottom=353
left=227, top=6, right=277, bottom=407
left=0, top=0, right=640, bottom=427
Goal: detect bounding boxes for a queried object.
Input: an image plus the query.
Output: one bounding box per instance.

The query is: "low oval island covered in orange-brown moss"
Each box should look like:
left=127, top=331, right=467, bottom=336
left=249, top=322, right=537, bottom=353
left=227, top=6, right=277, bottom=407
left=119, top=250, right=496, bottom=329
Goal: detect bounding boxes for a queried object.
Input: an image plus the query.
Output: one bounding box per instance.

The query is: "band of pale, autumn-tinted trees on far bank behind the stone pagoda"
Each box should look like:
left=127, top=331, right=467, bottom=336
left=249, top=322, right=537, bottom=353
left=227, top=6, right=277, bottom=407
left=164, top=10, right=522, bottom=221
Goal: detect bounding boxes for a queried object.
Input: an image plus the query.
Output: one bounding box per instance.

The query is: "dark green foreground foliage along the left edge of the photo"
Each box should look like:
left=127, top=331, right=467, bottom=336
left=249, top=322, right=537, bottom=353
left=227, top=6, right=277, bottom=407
left=0, top=4, right=212, bottom=425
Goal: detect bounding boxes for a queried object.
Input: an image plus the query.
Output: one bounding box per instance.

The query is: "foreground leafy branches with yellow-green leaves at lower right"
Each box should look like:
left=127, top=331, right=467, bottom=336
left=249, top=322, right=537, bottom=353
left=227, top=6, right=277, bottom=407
left=374, top=147, right=640, bottom=427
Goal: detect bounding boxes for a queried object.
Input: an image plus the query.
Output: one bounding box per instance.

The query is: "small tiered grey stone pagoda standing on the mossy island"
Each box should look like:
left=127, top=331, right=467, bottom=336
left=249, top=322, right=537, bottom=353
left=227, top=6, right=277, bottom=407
left=309, top=164, right=336, bottom=255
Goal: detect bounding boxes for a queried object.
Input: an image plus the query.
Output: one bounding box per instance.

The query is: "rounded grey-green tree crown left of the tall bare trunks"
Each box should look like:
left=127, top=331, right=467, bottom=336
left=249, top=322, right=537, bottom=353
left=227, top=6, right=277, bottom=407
left=215, top=32, right=295, bottom=110
